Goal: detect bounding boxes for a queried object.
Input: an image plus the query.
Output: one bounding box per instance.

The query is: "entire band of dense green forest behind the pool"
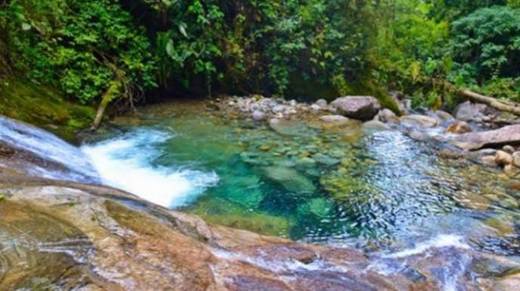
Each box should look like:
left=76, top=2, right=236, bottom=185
left=0, top=0, right=520, bottom=118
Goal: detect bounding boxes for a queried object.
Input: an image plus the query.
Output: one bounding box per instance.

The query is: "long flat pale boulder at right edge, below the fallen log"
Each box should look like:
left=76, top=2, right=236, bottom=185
left=452, top=124, right=520, bottom=150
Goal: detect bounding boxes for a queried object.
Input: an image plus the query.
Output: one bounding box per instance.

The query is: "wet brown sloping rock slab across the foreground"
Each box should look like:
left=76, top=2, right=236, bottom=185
left=0, top=175, right=517, bottom=290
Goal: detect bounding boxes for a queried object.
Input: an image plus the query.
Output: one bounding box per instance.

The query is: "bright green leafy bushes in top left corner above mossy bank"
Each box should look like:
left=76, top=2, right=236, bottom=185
left=2, top=0, right=155, bottom=103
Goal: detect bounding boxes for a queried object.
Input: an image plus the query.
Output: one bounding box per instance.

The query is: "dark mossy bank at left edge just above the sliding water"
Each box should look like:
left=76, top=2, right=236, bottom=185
left=0, top=78, right=95, bottom=140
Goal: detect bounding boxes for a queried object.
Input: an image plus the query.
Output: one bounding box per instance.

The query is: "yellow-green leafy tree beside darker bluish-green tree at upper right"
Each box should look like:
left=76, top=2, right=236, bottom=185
left=373, top=0, right=451, bottom=89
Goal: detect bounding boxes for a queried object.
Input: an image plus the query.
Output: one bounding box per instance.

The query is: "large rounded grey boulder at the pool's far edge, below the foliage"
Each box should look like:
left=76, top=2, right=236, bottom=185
left=331, top=96, right=381, bottom=120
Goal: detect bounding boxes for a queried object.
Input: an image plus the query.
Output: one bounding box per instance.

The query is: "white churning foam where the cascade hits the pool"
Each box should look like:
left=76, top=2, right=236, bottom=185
left=81, top=129, right=219, bottom=208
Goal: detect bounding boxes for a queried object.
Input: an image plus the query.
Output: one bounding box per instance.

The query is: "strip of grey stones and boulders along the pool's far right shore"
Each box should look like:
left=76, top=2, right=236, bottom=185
left=216, top=96, right=520, bottom=177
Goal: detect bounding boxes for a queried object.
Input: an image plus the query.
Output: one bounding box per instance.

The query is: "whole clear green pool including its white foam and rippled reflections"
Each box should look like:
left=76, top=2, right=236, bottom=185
left=83, top=104, right=520, bottom=255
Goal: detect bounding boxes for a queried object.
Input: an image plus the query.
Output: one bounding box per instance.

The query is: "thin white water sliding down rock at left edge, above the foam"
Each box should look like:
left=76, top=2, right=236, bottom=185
left=0, top=116, right=99, bottom=183
